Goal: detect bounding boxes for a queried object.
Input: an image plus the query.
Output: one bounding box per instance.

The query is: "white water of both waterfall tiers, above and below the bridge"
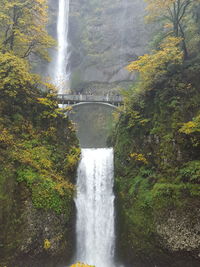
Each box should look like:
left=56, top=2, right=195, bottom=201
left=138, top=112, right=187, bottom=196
left=54, top=0, right=115, bottom=267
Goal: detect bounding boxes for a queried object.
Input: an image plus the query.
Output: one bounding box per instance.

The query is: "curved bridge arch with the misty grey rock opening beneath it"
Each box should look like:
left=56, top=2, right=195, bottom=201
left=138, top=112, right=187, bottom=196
left=67, top=102, right=117, bottom=148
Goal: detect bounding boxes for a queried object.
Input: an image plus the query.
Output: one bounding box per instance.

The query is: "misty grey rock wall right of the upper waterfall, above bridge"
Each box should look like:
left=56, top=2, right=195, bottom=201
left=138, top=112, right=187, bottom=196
left=69, top=0, right=149, bottom=93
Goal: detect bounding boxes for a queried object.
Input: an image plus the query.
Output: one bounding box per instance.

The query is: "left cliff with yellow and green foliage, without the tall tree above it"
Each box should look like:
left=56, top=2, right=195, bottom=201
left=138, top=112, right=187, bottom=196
left=0, top=57, right=80, bottom=267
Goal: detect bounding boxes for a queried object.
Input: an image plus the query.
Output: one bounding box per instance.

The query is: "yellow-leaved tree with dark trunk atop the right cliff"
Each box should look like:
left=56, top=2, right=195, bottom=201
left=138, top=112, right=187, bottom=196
left=146, top=0, right=199, bottom=58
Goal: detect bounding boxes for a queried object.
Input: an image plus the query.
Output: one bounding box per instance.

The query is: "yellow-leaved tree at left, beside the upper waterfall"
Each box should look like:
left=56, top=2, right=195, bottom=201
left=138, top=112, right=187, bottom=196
left=0, top=0, right=55, bottom=60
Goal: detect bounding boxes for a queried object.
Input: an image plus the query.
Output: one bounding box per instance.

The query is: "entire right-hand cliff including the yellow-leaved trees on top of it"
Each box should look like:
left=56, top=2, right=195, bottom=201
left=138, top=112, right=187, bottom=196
left=114, top=0, right=200, bottom=267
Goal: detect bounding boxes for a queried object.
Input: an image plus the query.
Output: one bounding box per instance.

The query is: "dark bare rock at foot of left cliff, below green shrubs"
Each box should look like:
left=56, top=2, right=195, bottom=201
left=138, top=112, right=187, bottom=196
left=0, top=184, right=75, bottom=267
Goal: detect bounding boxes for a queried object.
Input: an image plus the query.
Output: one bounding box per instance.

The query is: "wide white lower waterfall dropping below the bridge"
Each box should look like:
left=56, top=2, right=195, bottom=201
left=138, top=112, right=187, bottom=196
left=75, top=148, right=115, bottom=267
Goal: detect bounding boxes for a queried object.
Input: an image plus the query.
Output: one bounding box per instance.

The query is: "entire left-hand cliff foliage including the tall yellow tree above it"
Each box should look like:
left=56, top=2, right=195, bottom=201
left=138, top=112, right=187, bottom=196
left=0, top=0, right=80, bottom=266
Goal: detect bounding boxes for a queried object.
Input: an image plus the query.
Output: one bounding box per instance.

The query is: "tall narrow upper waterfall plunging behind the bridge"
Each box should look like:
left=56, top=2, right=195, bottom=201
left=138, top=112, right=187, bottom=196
left=53, top=0, right=70, bottom=94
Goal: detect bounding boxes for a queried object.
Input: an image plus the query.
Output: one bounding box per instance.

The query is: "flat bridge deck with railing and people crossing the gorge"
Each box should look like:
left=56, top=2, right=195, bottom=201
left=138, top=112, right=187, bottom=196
left=58, top=94, right=123, bottom=105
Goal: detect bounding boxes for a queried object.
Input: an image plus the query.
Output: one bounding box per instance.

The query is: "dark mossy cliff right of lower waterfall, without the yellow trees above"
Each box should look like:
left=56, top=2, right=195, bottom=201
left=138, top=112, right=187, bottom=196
left=114, top=60, right=200, bottom=267
